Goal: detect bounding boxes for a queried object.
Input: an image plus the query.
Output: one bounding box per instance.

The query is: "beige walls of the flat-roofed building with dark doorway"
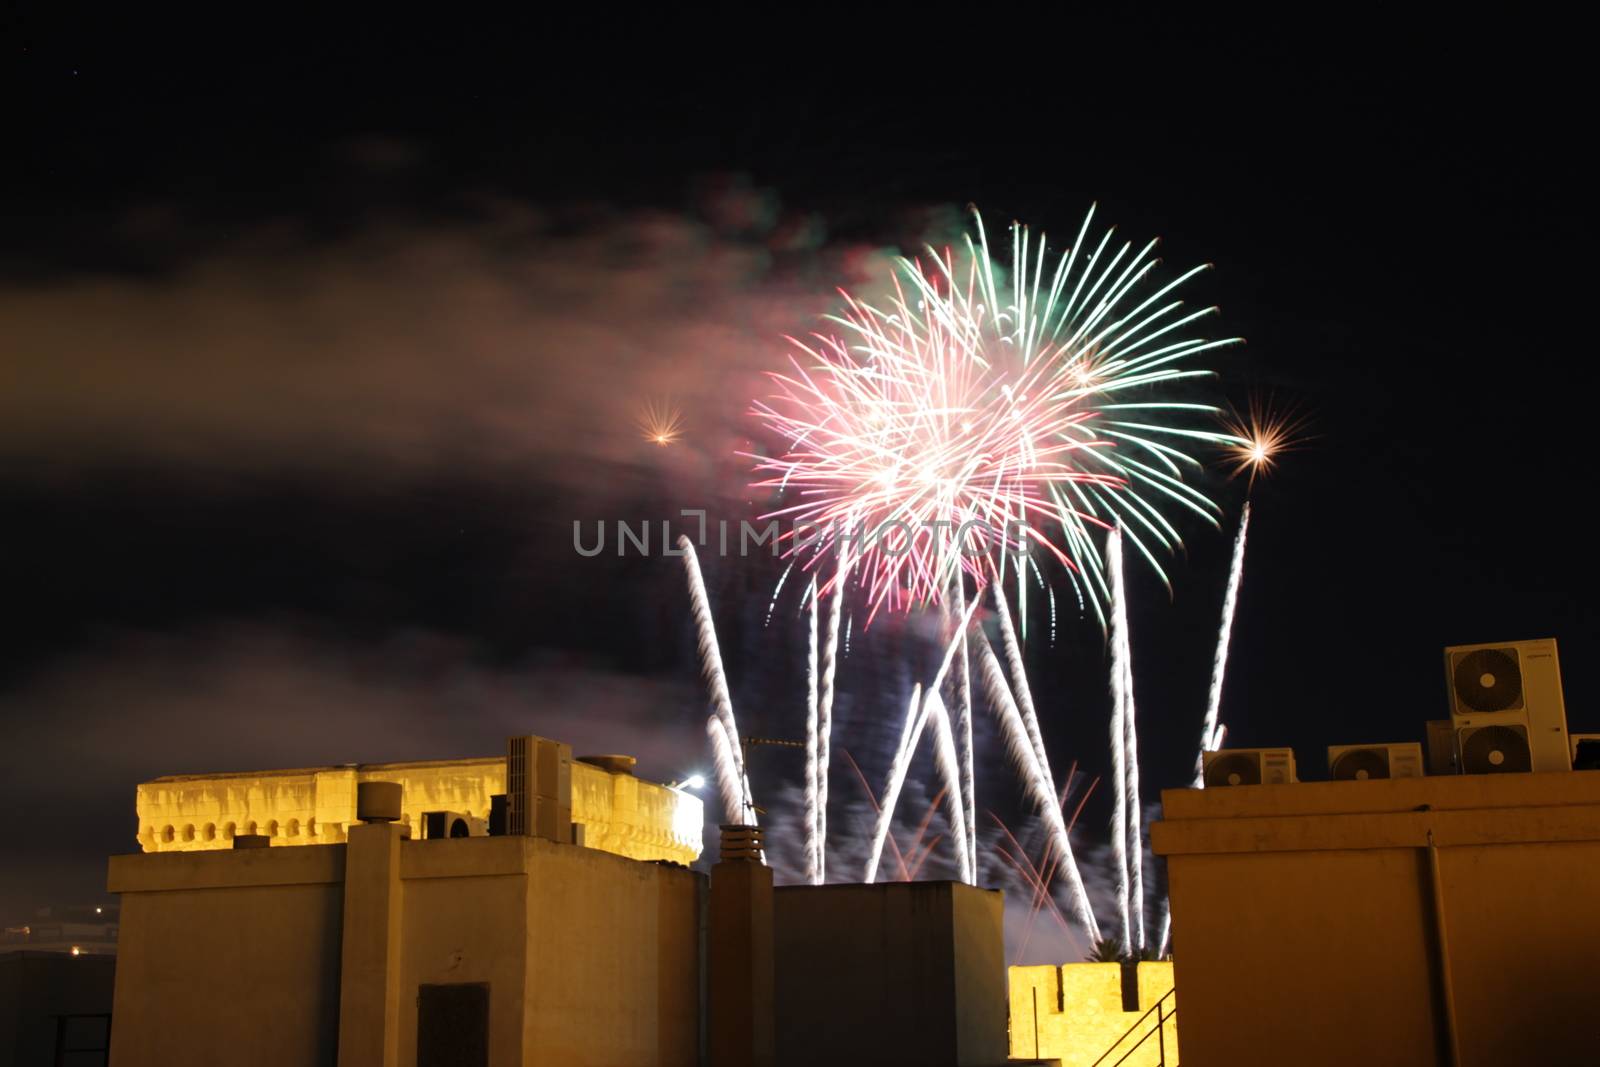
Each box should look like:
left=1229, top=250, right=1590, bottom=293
left=109, top=827, right=704, bottom=1067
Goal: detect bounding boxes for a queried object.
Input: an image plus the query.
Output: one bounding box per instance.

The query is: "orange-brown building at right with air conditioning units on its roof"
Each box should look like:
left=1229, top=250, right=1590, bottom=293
left=1150, top=771, right=1600, bottom=1067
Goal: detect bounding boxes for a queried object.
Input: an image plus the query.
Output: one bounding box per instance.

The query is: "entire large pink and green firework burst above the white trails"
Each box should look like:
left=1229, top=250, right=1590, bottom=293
left=755, top=210, right=1235, bottom=622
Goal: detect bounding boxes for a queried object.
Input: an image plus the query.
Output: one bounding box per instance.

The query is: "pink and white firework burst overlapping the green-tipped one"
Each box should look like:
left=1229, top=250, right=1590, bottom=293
left=757, top=266, right=1118, bottom=611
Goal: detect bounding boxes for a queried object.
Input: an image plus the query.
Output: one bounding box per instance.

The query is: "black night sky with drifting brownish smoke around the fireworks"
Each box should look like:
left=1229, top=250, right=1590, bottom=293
left=0, top=6, right=1600, bottom=940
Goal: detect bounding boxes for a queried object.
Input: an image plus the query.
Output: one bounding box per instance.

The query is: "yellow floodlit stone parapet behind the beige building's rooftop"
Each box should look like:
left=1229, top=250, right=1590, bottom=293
left=138, top=757, right=704, bottom=865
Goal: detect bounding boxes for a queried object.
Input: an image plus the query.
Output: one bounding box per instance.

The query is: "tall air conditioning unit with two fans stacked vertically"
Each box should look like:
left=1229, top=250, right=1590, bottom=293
left=1445, top=640, right=1573, bottom=774
